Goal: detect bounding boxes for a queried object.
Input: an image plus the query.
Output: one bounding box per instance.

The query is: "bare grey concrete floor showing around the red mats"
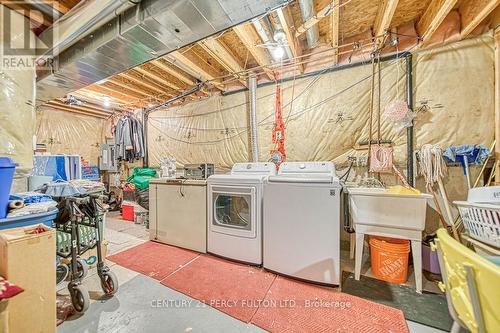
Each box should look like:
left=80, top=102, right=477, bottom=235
left=58, top=213, right=442, bottom=333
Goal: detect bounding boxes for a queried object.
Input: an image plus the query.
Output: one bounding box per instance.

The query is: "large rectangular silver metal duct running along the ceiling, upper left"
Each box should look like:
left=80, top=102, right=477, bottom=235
left=37, top=0, right=289, bottom=103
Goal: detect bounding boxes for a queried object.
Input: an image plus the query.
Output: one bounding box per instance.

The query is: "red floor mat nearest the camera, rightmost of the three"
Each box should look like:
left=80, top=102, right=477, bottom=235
left=251, top=277, right=408, bottom=333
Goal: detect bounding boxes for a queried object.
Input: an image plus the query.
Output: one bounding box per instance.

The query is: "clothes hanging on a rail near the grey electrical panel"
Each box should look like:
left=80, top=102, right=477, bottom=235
left=115, top=115, right=145, bottom=162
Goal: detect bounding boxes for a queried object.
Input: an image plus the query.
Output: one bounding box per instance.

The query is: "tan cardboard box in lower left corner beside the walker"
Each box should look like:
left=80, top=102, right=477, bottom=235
left=0, top=224, right=56, bottom=333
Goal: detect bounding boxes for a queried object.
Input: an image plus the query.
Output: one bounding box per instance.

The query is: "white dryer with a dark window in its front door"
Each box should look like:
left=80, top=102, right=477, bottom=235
left=207, top=163, right=276, bottom=265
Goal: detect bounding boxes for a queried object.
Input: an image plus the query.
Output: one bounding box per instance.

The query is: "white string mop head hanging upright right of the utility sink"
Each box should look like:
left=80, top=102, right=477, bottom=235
left=419, top=144, right=446, bottom=185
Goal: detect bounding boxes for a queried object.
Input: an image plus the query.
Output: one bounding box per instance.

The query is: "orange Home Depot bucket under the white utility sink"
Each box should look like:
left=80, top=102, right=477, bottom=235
left=370, top=236, right=410, bottom=283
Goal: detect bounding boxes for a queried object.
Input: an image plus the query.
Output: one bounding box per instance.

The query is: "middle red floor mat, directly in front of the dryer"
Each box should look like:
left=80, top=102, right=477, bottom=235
left=161, top=255, right=276, bottom=322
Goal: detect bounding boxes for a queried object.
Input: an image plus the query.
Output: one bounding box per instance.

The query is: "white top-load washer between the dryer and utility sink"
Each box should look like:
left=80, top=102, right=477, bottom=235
left=263, top=162, right=341, bottom=285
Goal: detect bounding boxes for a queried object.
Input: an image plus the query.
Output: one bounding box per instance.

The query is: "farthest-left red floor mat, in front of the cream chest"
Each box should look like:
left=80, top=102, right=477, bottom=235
left=107, top=242, right=199, bottom=280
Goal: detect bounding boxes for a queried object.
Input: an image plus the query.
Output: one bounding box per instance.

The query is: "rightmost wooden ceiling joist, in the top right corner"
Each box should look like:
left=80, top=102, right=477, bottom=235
left=458, top=0, right=500, bottom=38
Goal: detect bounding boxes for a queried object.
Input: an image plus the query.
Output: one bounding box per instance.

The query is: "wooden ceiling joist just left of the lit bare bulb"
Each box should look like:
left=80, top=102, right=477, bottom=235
left=233, top=23, right=274, bottom=80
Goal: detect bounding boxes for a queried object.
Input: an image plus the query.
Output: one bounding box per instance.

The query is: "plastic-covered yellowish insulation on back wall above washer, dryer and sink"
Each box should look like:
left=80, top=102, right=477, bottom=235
left=148, top=33, right=494, bottom=168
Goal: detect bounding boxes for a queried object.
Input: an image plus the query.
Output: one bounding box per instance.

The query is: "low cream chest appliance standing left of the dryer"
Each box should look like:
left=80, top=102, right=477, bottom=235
left=149, top=178, right=207, bottom=253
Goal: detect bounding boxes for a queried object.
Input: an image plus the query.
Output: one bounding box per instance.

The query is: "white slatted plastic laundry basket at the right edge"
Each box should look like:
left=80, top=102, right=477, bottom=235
left=453, top=201, right=500, bottom=248
